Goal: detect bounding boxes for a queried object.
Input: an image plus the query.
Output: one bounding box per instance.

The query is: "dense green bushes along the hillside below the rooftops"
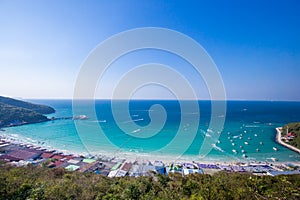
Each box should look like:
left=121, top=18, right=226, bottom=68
left=0, top=166, right=300, bottom=199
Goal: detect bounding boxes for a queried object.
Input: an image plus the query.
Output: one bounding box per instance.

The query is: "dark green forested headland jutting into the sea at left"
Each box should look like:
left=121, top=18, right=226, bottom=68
left=0, top=96, right=55, bottom=128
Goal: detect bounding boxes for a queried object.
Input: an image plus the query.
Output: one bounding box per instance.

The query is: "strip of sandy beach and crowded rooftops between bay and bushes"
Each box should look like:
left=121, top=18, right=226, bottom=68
left=0, top=130, right=300, bottom=177
